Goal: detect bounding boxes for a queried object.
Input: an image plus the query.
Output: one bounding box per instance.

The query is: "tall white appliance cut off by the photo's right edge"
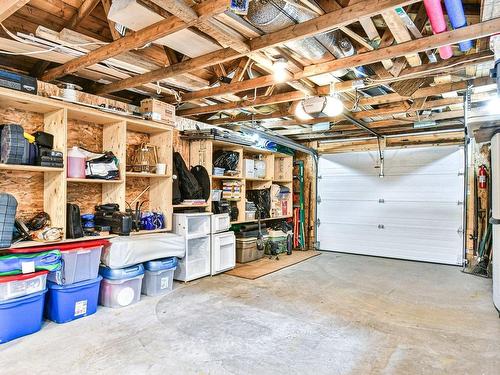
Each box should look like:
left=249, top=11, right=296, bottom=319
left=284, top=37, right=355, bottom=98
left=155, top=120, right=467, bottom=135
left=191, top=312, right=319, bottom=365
left=491, top=133, right=500, bottom=311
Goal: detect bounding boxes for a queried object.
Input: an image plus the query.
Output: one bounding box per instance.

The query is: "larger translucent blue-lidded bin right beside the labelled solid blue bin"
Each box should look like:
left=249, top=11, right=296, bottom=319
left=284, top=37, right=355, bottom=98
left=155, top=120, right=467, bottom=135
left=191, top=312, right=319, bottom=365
left=99, top=264, right=144, bottom=308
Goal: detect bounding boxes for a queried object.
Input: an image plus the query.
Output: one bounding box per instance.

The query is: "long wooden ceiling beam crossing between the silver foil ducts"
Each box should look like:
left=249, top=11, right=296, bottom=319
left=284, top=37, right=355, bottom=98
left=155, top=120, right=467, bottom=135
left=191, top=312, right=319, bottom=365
left=93, top=0, right=418, bottom=94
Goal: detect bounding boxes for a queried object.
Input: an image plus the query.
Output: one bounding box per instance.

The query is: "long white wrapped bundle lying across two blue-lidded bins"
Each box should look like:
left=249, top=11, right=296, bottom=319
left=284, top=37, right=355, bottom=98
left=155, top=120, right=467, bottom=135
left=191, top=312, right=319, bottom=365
left=101, top=233, right=186, bottom=269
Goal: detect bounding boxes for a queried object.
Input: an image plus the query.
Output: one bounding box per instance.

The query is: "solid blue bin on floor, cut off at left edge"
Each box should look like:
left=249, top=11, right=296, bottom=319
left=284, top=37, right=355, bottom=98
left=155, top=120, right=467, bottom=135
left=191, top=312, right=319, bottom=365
left=0, top=290, right=47, bottom=344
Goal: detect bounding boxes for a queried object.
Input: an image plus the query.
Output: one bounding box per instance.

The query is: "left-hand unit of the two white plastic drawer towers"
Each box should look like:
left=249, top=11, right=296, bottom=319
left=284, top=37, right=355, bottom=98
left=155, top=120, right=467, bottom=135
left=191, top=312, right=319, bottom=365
left=173, top=213, right=212, bottom=281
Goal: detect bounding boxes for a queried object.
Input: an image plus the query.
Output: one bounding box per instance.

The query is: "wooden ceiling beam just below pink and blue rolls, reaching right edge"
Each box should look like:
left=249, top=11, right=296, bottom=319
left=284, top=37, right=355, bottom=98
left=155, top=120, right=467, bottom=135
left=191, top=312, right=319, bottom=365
left=295, top=18, right=500, bottom=79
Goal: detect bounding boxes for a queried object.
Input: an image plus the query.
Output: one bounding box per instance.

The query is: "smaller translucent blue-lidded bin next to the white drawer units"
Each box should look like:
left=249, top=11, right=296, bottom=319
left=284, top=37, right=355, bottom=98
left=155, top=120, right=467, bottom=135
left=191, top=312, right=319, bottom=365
left=142, top=258, right=177, bottom=296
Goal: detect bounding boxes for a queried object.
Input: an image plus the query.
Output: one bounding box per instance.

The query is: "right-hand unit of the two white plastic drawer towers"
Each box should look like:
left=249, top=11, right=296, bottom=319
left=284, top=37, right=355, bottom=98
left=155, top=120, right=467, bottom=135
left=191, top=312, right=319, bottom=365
left=210, top=214, right=236, bottom=275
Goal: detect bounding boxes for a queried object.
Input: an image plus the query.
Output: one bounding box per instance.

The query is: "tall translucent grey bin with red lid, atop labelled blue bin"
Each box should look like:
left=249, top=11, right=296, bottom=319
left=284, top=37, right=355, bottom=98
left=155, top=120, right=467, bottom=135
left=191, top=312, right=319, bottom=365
left=48, top=244, right=102, bottom=285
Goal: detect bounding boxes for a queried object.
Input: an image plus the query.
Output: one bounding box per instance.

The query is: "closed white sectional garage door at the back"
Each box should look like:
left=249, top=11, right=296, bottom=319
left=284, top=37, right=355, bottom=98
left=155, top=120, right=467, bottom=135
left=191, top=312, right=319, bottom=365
left=318, top=146, right=464, bottom=264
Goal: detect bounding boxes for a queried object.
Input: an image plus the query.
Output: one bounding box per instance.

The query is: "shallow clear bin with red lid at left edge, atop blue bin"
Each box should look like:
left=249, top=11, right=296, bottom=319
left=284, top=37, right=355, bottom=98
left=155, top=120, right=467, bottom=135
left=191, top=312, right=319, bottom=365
left=0, top=271, right=48, bottom=301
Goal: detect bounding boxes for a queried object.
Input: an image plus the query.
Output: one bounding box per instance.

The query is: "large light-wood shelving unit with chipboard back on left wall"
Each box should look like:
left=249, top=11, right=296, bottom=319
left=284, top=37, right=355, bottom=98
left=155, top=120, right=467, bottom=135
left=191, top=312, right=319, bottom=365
left=0, top=88, right=173, bottom=247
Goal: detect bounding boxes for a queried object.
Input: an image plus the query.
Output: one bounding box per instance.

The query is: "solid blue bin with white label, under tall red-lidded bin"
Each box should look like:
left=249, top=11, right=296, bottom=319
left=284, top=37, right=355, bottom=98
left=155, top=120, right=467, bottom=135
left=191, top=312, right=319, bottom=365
left=45, top=276, right=102, bottom=323
